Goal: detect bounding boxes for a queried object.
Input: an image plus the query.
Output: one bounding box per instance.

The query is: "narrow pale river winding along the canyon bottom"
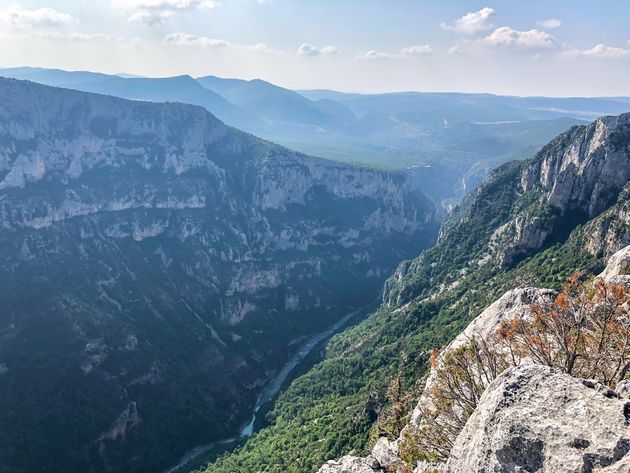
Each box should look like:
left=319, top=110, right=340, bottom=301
left=165, top=309, right=365, bottom=473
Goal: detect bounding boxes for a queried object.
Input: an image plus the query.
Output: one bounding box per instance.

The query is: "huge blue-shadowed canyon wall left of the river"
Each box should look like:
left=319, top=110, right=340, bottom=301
left=0, top=79, right=436, bottom=472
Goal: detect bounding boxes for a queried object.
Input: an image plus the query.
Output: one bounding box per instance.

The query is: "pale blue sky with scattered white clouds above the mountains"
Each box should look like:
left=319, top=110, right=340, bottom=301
left=0, top=0, right=630, bottom=96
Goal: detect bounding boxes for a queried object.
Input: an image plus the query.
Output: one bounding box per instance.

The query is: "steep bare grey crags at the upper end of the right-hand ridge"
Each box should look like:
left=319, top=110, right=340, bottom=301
left=493, top=114, right=630, bottom=265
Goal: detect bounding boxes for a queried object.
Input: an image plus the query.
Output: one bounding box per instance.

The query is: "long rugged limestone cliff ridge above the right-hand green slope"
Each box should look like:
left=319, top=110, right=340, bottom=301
left=383, top=114, right=630, bottom=309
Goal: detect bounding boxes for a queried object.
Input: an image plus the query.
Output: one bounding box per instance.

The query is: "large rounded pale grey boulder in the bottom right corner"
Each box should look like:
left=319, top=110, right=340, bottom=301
left=446, top=364, right=630, bottom=473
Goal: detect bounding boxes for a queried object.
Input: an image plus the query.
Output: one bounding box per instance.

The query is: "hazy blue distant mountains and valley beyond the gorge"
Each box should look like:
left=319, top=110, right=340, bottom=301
left=0, top=67, right=630, bottom=203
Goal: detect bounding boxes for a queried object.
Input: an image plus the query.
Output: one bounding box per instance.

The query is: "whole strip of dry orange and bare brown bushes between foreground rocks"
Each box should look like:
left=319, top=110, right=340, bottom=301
left=408, top=273, right=630, bottom=464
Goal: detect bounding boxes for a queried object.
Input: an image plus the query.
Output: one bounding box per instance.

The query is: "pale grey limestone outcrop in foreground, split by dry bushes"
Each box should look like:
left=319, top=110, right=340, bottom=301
left=319, top=246, right=630, bottom=473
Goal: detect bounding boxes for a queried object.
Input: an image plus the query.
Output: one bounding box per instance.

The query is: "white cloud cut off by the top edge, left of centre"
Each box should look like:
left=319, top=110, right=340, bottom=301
left=111, top=0, right=219, bottom=26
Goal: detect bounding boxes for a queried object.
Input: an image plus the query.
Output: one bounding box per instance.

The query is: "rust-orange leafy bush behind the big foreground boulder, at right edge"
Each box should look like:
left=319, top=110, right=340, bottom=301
left=496, top=273, right=630, bottom=387
